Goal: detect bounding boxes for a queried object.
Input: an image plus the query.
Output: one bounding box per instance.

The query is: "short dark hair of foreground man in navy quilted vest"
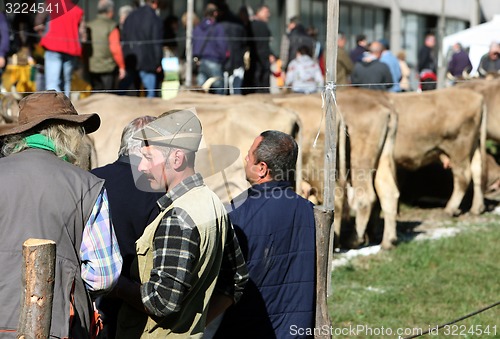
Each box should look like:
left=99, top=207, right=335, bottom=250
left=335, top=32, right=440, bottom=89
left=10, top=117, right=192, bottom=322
left=254, top=130, right=299, bottom=181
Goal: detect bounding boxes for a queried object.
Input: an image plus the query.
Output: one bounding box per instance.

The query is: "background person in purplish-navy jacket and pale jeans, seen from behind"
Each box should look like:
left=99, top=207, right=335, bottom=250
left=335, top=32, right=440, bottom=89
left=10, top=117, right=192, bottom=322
left=193, top=3, right=229, bottom=94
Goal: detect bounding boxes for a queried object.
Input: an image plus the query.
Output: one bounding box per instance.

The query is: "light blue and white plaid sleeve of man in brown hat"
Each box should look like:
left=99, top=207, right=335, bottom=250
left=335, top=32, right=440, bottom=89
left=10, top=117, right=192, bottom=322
left=80, top=188, right=123, bottom=291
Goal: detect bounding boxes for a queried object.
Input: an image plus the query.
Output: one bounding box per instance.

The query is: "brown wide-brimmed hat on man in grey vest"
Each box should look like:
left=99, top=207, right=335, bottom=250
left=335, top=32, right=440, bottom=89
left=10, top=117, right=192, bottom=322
left=0, top=90, right=101, bottom=136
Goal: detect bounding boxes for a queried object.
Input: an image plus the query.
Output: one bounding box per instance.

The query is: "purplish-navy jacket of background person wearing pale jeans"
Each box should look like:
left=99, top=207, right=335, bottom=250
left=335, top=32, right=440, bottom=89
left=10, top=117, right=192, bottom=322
left=193, top=19, right=229, bottom=64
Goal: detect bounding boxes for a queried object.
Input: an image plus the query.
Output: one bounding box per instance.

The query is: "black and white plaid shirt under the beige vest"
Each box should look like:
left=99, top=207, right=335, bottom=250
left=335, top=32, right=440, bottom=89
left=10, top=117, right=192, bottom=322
left=141, top=173, right=248, bottom=316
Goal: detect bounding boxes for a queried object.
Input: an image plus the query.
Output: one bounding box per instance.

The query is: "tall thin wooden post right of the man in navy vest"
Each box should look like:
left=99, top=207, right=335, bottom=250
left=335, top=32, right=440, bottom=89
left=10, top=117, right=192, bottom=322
left=314, top=0, right=339, bottom=339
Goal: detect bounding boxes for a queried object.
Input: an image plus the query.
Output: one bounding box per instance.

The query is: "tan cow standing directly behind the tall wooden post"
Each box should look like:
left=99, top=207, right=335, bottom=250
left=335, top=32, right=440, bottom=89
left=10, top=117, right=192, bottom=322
left=273, top=89, right=399, bottom=249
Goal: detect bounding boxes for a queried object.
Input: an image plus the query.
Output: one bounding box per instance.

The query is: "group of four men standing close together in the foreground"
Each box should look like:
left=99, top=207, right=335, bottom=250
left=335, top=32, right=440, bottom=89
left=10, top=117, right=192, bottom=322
left=0, top=90, right=316, bottom=339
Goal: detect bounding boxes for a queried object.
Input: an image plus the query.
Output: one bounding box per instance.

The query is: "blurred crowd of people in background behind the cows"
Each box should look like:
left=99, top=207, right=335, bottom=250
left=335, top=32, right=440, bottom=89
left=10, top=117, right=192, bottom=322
left=0, top=0, right=500, bottom=97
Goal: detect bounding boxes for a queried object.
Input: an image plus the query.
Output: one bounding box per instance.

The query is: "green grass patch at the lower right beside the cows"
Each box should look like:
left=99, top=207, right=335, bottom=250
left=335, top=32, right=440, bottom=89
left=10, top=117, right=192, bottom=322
left=328, top=222, right=500, bottom=338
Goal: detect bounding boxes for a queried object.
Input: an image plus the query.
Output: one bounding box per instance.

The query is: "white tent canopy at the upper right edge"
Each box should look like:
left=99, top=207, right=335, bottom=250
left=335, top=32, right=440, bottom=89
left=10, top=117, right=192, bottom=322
left=442, top=15, right=500, bottom=75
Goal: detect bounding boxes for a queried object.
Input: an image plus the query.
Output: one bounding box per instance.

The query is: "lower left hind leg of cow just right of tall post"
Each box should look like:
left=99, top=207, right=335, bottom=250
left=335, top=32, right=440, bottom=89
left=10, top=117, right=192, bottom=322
left=352, top=169, right=377, bottom=246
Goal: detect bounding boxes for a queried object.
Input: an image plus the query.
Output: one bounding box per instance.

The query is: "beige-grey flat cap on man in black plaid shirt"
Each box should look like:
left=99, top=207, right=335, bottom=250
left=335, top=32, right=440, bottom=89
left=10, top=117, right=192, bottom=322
left=133, top=110, right=202, bottom=152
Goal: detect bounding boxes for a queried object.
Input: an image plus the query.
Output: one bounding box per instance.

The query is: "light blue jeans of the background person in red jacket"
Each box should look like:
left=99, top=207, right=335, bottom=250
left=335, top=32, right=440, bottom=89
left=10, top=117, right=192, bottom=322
left=45, top=51, right=75, bottom=97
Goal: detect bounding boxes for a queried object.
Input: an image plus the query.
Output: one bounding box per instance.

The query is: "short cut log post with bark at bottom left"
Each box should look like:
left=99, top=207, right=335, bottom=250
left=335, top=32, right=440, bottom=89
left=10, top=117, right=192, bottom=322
left=17, top=239, right=56, bottom=339
